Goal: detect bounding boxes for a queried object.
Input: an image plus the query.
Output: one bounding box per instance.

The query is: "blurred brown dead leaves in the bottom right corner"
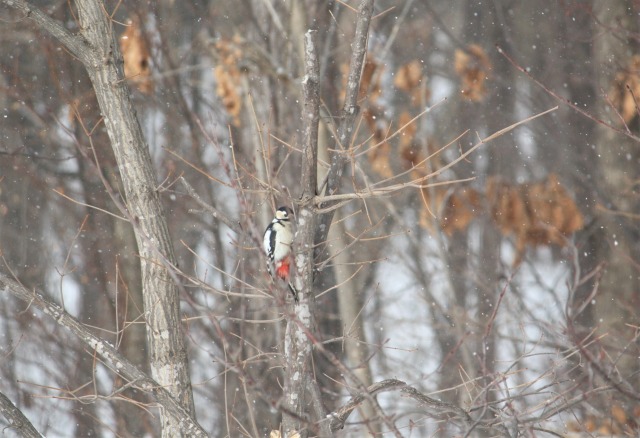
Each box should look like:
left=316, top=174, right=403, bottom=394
left=568, top=403, right=640, bottom=436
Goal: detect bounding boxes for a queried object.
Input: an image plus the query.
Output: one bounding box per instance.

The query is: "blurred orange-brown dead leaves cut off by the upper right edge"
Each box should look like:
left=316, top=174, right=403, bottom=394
left=609, top=55, right=640, bottom=124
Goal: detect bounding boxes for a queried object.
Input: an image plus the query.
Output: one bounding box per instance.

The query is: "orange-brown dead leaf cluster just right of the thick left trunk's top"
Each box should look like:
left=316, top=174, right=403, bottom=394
left=120, top=19, right=154, bottom=94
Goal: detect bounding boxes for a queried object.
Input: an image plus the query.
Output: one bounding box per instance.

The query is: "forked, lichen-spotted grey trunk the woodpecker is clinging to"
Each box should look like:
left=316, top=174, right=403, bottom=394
left=283, top=0, right=373, bottom=436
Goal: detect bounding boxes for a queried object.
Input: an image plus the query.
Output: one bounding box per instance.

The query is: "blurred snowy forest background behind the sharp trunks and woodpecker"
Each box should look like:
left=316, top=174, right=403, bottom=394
left=0, top=0, right=640, bottom=437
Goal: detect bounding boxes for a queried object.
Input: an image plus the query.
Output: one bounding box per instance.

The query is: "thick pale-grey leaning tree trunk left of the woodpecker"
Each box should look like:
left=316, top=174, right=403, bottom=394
left=70, top=0, right=195, bottom=436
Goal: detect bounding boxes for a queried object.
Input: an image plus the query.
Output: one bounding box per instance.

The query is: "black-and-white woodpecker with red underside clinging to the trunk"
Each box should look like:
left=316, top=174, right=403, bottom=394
left=262, top=207, right=298, bottom=303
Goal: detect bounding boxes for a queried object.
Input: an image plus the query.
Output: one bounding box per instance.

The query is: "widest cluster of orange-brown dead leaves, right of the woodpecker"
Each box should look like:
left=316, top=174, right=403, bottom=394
left=420, top=174, right=584, bottom=264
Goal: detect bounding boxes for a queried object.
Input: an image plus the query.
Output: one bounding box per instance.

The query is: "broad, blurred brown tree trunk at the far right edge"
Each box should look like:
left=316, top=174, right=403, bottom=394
left=592, top=0, right=640, bottom=394
